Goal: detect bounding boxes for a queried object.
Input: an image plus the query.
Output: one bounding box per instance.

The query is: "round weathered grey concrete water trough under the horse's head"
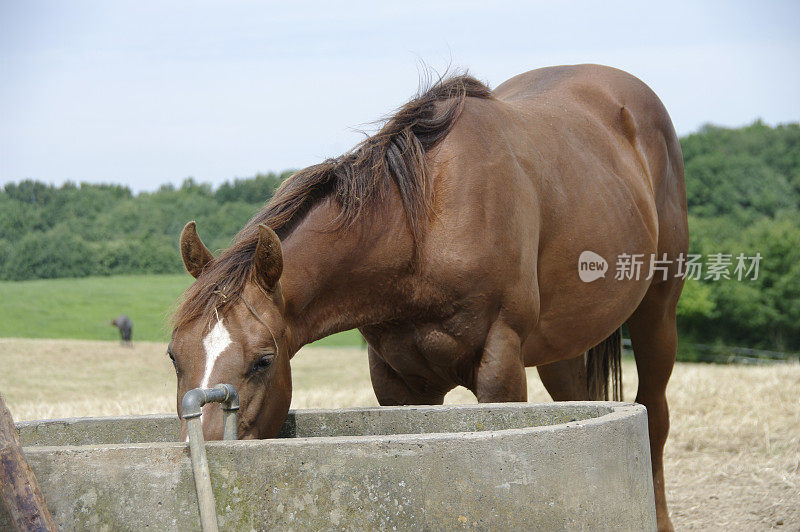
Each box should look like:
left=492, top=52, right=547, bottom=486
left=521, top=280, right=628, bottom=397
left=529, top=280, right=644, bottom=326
left=0, top=402, right=655, bottom=531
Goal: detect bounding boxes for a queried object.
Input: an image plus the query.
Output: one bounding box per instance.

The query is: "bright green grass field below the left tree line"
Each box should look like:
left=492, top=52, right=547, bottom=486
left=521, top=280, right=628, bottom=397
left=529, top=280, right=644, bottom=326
left=0, top=274, right=361, bottom=347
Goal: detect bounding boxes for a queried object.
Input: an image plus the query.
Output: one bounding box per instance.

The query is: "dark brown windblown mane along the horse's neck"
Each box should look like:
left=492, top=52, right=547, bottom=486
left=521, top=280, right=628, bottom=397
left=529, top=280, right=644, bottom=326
left=172, top=75, right=492, bottom=327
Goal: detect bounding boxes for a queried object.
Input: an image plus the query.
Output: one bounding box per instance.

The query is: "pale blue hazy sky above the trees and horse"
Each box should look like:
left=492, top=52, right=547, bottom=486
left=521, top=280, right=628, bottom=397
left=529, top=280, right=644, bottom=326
left=0, top=0, right=800, bottom=191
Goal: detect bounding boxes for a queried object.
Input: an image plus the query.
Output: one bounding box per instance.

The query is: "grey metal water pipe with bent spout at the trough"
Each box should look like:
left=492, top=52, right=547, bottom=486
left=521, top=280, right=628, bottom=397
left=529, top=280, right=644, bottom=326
left=181, top=384, right=239, bottom=532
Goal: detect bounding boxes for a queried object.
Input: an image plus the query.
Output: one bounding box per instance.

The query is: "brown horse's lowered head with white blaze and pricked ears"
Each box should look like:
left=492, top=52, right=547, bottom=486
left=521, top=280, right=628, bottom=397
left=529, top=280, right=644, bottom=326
left=167, top=222, right=292, bottom=440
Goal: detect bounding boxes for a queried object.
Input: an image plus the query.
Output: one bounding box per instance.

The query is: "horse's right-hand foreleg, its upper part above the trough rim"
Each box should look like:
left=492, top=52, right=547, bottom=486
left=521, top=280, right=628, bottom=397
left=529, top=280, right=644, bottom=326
left=472, top=320, right=528, bottom=403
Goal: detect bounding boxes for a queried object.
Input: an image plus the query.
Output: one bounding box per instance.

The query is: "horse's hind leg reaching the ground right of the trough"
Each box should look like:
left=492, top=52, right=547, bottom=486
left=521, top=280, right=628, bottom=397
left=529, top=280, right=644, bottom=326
left=627, top=279, right=683, bottom=530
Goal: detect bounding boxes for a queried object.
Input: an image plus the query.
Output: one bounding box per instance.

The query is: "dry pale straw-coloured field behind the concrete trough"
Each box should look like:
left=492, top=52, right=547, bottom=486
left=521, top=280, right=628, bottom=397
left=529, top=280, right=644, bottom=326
left=0, top=339, right=800, bottom=530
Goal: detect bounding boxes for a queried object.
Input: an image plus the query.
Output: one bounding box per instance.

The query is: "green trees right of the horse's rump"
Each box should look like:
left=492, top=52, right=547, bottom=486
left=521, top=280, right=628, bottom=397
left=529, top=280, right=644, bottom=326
left=678, top=121, right=800, bottom=352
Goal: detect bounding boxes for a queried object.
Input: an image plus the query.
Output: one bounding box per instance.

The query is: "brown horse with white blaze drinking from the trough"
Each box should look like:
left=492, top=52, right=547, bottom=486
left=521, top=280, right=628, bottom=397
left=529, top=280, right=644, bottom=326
left=169, top=65, right=688, bottom=529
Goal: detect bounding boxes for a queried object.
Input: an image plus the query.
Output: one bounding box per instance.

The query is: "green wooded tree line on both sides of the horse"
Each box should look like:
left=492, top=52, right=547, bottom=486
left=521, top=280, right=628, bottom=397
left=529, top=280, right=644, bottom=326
left=0, top=121, right=800, bottom=351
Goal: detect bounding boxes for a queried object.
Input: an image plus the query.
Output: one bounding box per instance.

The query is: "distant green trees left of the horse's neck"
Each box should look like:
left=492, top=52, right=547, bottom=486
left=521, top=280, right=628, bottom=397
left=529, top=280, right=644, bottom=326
left=0, top=172, right=289, bottom=281
